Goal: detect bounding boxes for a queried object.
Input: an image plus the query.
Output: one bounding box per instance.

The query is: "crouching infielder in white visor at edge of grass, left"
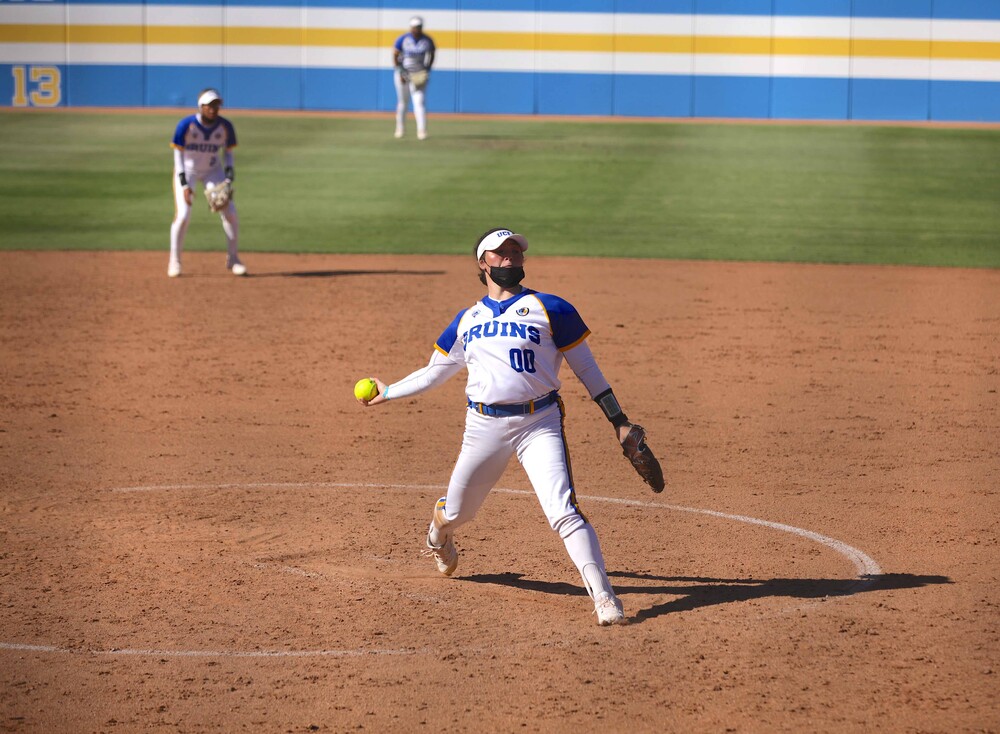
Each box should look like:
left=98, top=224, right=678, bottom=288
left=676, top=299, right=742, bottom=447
left=167, top=89, right=247, bottom=278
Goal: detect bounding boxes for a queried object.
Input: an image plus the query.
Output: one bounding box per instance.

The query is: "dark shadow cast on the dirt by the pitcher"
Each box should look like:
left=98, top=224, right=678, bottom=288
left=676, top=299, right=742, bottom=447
left=461, top=571, right=954, bottom=623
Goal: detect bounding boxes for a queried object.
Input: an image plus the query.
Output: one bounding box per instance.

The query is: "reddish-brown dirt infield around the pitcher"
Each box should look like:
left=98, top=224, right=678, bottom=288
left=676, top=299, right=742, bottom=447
left=0, top=252, right=1000, bottom=732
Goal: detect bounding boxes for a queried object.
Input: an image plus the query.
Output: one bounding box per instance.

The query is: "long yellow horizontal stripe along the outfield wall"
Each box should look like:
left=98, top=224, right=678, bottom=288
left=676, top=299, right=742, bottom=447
left=0, top=24, right=1000, bottom=61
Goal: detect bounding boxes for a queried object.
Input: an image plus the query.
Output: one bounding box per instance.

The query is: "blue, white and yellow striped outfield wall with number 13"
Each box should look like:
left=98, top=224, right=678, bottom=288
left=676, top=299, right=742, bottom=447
left=0, top=0, right=1000, bottom=122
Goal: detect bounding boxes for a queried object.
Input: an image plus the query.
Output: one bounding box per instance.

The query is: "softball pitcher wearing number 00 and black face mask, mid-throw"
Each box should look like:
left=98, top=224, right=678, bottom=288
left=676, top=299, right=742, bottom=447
left=359, top=229, right=648, bottom=625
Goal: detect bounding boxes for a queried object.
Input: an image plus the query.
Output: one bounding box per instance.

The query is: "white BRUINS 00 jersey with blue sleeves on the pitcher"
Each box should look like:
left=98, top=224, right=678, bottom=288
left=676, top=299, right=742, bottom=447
left=434, top=288, right=590, bottom=404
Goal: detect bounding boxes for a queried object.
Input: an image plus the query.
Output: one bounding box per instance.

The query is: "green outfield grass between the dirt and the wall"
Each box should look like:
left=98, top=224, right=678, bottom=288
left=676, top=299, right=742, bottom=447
left=0, top=112, right=1000, bottom=268
